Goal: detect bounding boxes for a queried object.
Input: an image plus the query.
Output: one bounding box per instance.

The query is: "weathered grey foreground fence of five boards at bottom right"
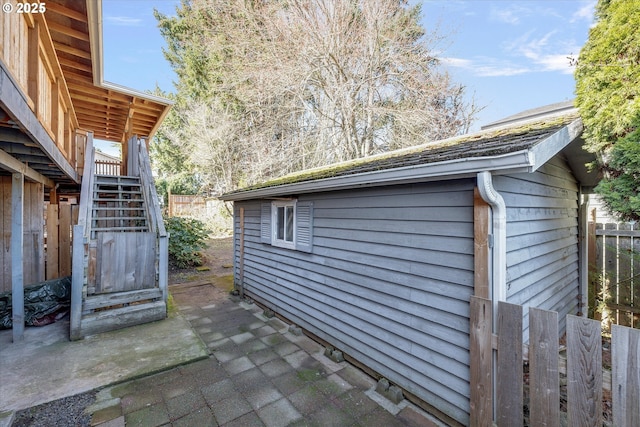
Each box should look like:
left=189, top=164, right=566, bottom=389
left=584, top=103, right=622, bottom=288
left=470, top=296, right=640, bottom=427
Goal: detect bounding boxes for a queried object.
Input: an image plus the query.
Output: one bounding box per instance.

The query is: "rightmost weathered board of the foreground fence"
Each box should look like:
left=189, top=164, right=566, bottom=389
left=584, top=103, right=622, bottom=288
left=611, top=325, right=640, bottom=426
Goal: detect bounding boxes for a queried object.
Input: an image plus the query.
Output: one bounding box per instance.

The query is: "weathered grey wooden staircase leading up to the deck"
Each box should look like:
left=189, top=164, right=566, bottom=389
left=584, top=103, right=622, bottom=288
left=71, top=138, right=168, bottom=340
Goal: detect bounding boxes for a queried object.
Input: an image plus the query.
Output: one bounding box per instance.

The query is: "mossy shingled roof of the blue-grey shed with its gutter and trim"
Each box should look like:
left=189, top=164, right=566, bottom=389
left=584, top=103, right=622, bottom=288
left=220, top=109, right=597, bottom=200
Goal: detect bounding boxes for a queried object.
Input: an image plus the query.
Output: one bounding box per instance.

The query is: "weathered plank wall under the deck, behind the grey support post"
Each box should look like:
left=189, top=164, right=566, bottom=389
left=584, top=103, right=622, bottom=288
left=0, top=176, right=44, bottom=292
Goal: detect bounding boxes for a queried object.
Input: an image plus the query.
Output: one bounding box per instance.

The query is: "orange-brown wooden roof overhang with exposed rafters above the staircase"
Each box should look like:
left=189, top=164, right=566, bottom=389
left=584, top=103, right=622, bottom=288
left=45, top=0, right=173, bottom=142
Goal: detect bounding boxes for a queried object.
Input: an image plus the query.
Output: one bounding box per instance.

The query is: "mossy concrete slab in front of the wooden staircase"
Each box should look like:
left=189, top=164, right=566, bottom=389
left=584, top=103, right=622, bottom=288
left=0, top=314, right=209, bottom=411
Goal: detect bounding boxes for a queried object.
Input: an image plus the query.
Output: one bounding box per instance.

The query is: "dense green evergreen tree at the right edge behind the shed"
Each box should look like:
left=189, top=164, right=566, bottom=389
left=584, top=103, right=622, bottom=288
left=575, top=0, right=640, bottom=220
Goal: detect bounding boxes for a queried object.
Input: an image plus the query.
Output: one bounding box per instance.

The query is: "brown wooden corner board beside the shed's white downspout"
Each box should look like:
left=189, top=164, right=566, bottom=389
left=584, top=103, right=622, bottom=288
left=473, top=187, right=491, bottom=298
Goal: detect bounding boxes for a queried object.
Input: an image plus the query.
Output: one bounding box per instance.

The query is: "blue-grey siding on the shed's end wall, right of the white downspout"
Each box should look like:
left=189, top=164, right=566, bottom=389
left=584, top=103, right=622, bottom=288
left=494, top=157, right=580, bottom=341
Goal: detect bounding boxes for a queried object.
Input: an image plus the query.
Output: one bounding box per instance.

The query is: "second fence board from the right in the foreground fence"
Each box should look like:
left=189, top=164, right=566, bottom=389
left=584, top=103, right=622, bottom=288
left=567, top=315, right=602, bottom=427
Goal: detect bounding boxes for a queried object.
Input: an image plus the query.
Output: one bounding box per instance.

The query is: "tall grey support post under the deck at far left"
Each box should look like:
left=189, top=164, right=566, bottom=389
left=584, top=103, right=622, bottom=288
left=11, top=173, right=24, bottom=342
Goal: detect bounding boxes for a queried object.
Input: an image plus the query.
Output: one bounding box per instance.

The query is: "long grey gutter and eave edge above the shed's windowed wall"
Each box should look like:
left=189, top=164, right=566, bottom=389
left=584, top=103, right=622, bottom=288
left=219, top=150, right=534, bottom=201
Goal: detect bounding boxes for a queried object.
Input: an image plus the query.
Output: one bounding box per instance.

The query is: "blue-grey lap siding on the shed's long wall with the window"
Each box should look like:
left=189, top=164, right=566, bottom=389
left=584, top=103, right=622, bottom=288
left=236, top=181, right=473, bottom=424
